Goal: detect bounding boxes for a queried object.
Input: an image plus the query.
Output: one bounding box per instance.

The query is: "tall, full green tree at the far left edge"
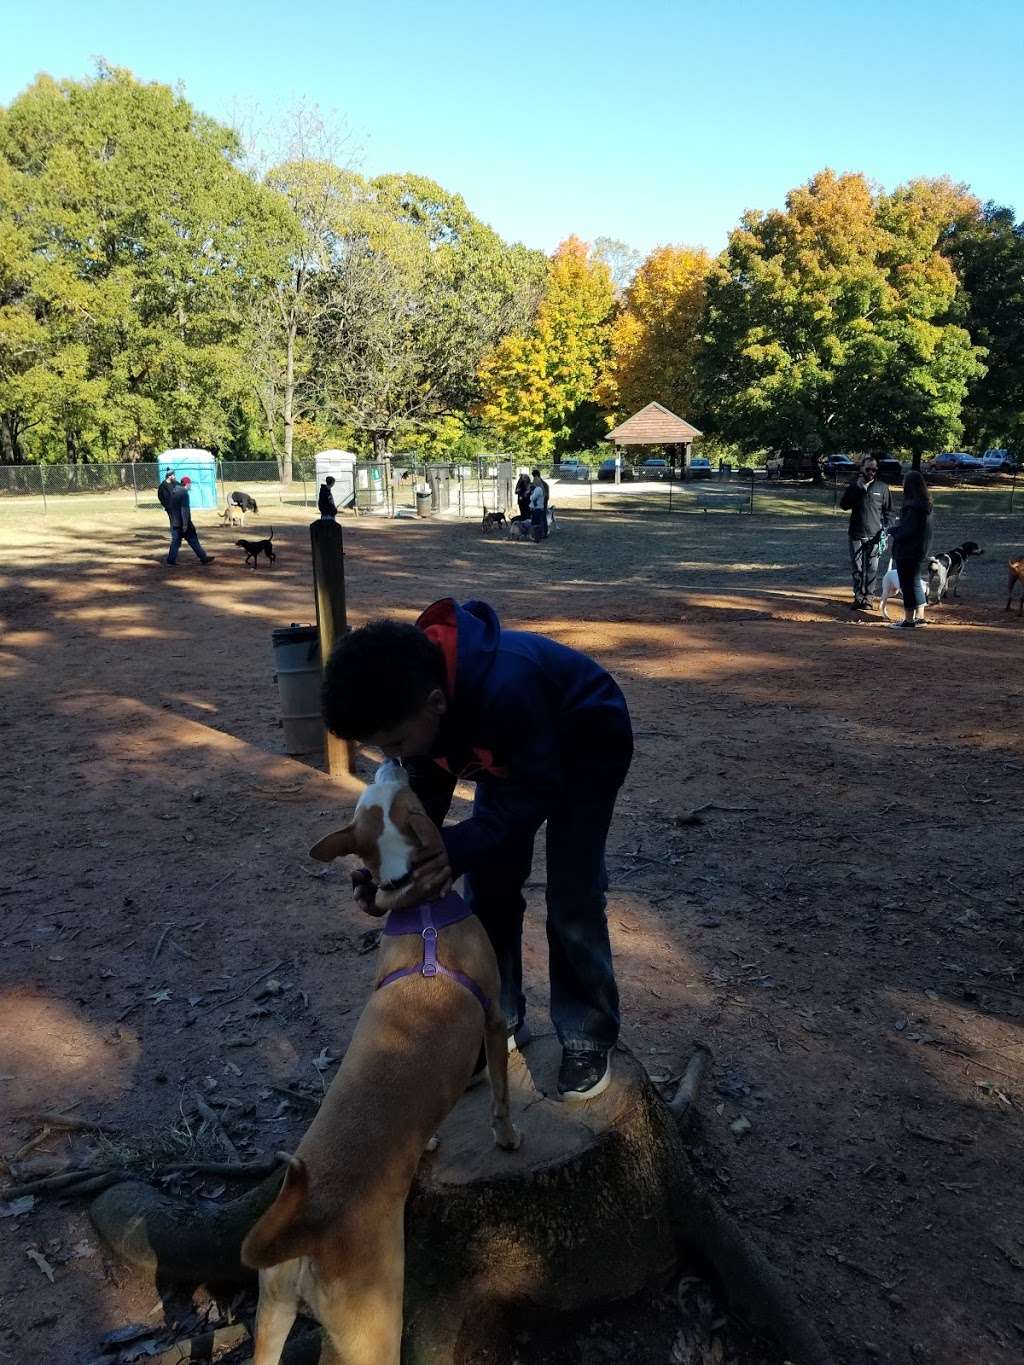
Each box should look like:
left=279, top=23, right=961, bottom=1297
left=0, top=67, right=287, bottom=459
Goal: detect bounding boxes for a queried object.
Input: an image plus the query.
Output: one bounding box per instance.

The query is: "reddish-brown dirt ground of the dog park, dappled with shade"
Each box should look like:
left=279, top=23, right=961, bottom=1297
left=0, top=498, right=1024, bottom=1365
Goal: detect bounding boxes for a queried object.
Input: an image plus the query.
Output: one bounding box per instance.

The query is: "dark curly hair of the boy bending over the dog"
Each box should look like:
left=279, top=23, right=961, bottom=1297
left=321, top=620, right=445, bottom=740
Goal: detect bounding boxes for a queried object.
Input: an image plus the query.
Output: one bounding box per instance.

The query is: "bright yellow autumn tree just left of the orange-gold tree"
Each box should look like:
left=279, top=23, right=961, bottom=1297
left=478, top=238, right=614, bottom=456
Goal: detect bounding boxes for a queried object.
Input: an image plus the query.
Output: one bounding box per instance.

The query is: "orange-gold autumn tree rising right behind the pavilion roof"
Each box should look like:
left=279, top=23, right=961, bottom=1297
left=598, top=247, right=711, bottom=416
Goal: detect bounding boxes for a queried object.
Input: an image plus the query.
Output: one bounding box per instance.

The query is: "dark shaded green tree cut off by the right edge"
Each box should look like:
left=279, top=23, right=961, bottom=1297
left=945, top=203, right=1024, bottom=453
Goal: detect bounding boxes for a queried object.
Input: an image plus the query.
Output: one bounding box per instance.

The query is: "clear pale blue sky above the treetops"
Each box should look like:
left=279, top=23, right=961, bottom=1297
left=0, top=0, right=1024, bottom=251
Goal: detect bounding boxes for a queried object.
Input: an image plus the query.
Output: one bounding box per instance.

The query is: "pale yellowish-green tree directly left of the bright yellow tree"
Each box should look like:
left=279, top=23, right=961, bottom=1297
left=304, top=176, right=543, bottom=456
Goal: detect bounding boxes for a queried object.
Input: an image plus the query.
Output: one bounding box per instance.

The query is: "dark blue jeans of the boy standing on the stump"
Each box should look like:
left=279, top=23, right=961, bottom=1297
left=466, top=784, right=618, bottom=1050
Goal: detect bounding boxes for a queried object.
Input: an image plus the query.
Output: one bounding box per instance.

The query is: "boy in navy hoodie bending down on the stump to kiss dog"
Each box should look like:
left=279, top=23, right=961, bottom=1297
left=324, top=598, right=634, bottom=1099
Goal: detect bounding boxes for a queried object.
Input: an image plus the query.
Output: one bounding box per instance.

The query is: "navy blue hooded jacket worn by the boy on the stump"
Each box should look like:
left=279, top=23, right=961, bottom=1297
left=406, top=598, right=634, bottom=876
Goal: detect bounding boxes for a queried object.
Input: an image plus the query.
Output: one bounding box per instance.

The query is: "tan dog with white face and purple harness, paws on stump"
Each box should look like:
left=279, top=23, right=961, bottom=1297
left=242, top=763, right=519, bottom=1365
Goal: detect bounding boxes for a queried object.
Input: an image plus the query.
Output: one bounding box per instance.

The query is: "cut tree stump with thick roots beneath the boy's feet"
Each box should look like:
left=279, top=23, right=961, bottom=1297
left=91, top=1037, right=827, bottom=1365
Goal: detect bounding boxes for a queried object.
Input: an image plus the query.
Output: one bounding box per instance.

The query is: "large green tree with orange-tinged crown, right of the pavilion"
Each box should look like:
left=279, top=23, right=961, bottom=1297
left=700, top=171, right=983, bottom=463
